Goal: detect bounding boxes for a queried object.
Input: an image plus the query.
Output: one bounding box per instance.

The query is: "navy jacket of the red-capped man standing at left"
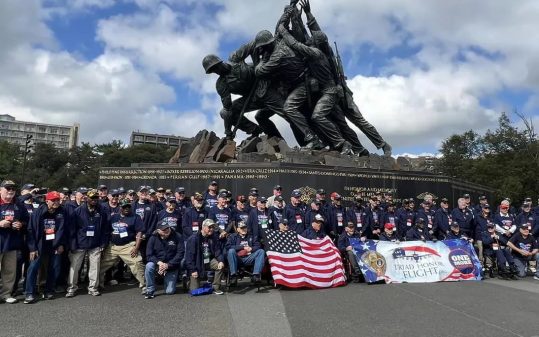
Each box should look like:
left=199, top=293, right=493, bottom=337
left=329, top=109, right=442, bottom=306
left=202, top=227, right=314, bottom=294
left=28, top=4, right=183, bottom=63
left=26, top=204, right=68, bottom=253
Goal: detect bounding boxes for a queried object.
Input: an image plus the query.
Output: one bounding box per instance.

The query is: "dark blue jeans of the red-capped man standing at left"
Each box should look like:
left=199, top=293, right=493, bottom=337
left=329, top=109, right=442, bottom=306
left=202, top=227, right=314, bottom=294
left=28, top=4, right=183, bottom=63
left=25, top=252, right=62, bottom=296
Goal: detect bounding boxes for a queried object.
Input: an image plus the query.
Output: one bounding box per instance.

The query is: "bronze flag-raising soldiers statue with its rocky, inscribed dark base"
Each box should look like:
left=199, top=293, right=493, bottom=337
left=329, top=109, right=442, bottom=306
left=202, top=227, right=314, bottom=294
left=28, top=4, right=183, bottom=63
left=100, top=0, right=492, bottom=202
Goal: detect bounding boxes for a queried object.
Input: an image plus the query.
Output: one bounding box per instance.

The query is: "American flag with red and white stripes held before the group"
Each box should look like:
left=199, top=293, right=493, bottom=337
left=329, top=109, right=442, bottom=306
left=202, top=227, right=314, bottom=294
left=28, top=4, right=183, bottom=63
left=266, top=230, right=346, bottom=288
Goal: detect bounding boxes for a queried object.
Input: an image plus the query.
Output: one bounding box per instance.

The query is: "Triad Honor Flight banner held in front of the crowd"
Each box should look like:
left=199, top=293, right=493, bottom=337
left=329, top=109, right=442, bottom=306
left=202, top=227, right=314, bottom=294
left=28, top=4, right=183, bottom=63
left=350, top=239, right=481, bottom=283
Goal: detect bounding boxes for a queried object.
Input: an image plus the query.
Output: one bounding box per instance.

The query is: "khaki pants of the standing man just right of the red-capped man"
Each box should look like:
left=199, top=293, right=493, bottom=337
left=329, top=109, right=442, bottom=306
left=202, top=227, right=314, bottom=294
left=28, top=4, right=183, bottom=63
left=67, top=247, right=101, bottom=292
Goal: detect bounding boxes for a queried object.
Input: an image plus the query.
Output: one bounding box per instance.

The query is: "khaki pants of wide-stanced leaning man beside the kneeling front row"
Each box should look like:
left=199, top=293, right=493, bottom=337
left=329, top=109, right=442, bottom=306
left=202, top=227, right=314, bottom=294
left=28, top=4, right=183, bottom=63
left=99, top=241, right=145, bottom=288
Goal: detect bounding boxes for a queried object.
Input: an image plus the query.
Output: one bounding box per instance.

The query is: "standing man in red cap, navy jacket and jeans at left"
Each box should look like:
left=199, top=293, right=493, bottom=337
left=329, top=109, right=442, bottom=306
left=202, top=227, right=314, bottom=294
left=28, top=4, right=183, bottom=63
left=24, top=191, right=66, bottom=304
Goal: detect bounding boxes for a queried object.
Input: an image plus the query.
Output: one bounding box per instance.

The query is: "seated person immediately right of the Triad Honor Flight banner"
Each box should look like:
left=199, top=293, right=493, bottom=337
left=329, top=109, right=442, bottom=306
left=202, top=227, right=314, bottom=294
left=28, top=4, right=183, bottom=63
left=482, top=222, right=517, bottom=279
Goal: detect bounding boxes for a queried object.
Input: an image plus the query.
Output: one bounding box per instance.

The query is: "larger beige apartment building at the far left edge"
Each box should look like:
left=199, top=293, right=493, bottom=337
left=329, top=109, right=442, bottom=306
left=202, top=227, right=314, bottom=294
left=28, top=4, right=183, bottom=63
left=0, top=114, right=80, bottom=149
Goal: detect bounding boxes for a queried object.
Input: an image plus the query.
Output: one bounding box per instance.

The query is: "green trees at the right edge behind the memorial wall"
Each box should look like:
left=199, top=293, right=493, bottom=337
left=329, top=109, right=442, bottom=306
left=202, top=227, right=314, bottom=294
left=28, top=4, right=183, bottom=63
left=437, top=112, right=539, bottom=203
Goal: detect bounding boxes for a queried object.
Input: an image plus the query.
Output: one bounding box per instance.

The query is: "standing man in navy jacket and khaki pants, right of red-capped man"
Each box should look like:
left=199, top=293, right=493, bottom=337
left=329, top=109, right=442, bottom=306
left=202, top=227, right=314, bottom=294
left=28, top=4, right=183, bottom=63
left=66, top=190, right=109, bottom=297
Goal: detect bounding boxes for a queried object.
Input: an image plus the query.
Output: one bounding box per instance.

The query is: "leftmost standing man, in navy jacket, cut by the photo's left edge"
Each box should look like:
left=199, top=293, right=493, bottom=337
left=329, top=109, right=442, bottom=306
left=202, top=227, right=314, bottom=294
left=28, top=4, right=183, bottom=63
left=0, top=180, right=29, bottom=304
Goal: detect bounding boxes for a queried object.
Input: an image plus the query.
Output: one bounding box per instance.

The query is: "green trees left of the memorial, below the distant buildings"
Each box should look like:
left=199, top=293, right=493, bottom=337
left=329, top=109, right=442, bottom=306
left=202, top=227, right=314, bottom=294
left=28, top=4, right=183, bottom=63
left=0, top=140, right=175, bottom=189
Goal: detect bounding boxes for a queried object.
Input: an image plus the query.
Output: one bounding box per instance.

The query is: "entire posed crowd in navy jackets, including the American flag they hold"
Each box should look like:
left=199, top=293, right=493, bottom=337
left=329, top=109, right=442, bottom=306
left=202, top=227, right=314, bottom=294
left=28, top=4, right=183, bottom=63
left=0, top=180, right=539, bottom=303
